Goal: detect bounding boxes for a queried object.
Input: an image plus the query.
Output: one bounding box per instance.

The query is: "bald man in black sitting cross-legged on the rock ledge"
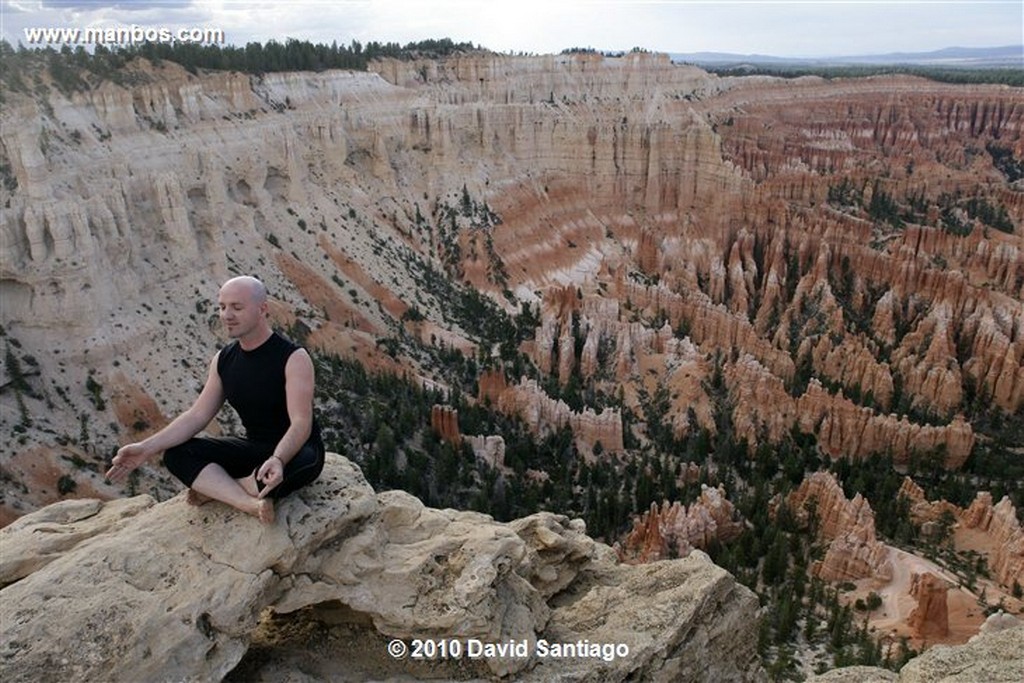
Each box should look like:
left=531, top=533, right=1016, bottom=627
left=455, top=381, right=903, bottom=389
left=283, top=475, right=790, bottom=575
left=106, top=276, right=324, bottom=524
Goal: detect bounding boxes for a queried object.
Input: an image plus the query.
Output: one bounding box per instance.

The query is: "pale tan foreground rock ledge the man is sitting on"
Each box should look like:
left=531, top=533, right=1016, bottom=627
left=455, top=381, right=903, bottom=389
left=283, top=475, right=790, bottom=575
left=0, top=454, right=766, bottom=681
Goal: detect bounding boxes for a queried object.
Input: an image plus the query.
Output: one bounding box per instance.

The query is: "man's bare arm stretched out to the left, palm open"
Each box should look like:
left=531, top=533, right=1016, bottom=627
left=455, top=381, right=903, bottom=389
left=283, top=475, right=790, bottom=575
left=106, top=353, right=224, bottom=481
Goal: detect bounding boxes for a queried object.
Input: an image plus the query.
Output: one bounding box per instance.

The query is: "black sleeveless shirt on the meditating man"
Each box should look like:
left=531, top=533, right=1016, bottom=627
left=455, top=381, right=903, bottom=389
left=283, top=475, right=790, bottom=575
left=217, top=332, right=319, bottom=444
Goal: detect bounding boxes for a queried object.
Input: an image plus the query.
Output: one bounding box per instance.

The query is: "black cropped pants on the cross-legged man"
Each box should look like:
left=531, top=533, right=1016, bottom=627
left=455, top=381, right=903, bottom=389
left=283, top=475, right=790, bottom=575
left=164, top=436, right=324, bottom=498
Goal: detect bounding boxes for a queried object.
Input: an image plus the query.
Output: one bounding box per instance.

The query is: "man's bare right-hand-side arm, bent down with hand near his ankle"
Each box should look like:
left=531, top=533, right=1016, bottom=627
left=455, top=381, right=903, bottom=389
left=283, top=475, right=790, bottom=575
left=256, top=349, right=315, bottom=498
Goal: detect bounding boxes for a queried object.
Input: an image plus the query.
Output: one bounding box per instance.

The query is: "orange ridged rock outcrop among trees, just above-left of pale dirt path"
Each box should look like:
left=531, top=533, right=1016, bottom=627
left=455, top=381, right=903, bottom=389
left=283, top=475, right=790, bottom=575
left=786, top=472, right=893, bottom=582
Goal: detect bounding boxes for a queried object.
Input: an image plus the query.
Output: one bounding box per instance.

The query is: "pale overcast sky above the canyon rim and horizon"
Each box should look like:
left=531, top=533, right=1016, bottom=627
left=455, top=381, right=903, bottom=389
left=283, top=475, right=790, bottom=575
left=0, top=0, right=1024, bottom=56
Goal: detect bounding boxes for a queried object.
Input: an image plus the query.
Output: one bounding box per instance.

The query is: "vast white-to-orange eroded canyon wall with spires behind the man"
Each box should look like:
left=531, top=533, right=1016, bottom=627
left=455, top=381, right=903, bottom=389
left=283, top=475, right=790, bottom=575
left=0, top=54, right=1024, bottom=518
